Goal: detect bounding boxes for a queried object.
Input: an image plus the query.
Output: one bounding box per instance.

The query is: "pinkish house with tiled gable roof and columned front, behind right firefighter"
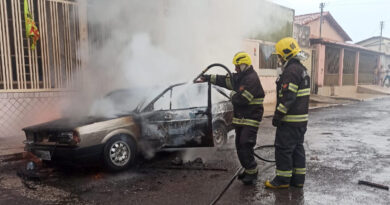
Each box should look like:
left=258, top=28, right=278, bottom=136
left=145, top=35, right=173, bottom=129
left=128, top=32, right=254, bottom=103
left=294, top=12, right=380, bottom=95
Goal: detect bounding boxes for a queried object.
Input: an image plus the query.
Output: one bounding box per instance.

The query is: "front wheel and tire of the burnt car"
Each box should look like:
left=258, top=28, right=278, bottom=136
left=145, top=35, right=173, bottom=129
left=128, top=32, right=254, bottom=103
left=103, top=135, right=137, bottom=171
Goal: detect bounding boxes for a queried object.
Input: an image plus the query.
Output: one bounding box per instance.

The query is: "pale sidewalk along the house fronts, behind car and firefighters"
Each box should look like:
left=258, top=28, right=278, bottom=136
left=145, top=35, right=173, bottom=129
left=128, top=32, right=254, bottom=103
left=0, top=92, right=390, bottom=161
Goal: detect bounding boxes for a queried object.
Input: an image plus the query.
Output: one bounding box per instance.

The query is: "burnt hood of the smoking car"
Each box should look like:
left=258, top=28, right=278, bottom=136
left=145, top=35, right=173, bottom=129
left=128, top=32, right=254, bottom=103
left=23, top=116, right=133, bottom=132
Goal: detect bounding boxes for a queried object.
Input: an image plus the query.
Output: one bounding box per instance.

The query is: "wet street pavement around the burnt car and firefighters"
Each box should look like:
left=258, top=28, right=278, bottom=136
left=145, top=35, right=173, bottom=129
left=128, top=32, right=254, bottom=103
left=0, top=98, right=390, bottom=204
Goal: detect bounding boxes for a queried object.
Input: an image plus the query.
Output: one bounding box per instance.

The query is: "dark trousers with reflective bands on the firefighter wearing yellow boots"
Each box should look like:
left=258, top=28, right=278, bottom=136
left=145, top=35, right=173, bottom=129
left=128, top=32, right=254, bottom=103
left=275, top=125, right=306, bottom=185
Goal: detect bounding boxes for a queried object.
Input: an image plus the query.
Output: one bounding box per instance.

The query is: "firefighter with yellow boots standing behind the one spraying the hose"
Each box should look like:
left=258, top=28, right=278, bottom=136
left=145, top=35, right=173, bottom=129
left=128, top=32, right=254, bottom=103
left=265, top=37, right=310, bottom=189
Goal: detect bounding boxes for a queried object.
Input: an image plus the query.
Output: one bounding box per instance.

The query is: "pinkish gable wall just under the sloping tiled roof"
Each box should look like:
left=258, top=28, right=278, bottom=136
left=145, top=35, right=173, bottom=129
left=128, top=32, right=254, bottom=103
left=307, top=18, right=345, bottom=42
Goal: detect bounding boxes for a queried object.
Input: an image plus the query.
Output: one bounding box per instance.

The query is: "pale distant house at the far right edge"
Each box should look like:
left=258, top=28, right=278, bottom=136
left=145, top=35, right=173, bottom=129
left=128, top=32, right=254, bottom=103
left=356, top=36, right=390, bottom=69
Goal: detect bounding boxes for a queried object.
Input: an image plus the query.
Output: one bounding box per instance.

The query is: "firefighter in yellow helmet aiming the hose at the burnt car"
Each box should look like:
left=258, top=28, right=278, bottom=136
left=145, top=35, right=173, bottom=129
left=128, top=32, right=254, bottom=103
left=201, top=52, right=264, bottom=185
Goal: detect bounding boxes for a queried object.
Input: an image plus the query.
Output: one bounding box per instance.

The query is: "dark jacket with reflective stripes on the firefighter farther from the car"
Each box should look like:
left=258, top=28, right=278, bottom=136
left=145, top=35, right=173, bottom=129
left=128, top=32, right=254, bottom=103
left=274, top=59, right=310, bottom=127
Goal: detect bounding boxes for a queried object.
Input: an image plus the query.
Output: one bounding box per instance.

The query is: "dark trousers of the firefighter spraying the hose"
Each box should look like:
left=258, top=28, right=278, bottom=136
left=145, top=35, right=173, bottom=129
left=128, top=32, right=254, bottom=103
left=235, top=126, right=259, bottom=170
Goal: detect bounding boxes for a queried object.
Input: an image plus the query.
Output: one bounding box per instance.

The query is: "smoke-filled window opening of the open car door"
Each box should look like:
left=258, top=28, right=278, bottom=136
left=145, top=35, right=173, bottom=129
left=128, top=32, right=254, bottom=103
left=171, top=83, right=207, bottom=109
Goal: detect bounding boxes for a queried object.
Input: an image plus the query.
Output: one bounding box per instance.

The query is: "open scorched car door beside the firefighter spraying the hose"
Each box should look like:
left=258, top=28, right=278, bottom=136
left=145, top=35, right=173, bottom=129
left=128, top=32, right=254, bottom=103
left=166, top=83, right=214, bottom=147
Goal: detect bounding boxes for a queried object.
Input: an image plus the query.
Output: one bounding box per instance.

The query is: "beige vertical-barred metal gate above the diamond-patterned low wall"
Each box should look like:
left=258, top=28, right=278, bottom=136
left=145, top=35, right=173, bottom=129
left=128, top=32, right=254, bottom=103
left=0, top=0, right=81, bottom=92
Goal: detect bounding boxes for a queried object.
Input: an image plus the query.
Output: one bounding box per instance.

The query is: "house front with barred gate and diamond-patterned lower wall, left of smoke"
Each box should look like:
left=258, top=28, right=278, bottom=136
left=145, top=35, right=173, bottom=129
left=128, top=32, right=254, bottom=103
left=0, top=0, right=88, bottom=137
